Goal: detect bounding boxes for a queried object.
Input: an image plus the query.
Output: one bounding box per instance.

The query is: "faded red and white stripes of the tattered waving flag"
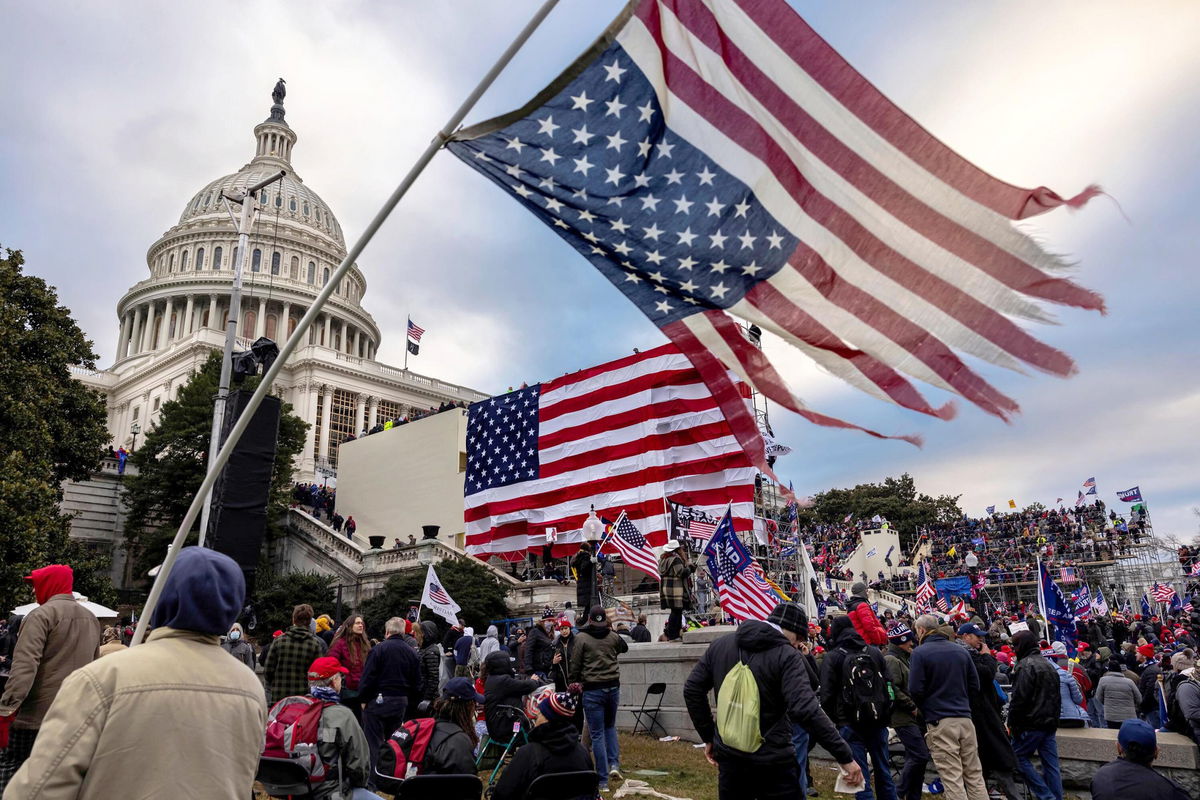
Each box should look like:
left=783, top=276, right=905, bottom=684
left=617, top=0, right=1104, bottom=450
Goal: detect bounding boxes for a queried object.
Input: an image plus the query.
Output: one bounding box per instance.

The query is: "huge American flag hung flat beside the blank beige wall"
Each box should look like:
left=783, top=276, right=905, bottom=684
left=464, top=344, right=756, bottom=560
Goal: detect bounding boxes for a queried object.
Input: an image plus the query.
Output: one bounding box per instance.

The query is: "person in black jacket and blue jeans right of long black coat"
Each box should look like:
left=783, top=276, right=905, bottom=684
left=1008, top=631, right=1062, bottom=800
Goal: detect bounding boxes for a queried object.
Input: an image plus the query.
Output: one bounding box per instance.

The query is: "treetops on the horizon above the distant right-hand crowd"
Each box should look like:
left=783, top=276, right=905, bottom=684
left=800, top=473, right=962, bottom=545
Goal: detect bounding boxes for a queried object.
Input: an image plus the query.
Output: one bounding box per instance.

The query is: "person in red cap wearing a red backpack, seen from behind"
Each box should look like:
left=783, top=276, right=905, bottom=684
left=263, top=656, right=382, bottom=800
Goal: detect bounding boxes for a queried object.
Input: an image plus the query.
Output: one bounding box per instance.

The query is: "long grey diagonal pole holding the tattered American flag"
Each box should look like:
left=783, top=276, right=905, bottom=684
left=130, top=0, right=558, bottom=645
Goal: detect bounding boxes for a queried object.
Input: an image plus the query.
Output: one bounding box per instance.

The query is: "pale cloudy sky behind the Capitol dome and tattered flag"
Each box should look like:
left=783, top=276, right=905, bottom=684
left=0, top=0, right=1200, bottom=536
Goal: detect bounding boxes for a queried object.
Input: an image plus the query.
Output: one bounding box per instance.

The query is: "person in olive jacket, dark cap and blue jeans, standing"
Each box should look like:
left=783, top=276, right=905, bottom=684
left=568, top=606, right=629, bottom=790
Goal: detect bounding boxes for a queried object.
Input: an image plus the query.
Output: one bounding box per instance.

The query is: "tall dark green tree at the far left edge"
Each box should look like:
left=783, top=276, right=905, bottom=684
left=0, top=249, right=115, bottom=609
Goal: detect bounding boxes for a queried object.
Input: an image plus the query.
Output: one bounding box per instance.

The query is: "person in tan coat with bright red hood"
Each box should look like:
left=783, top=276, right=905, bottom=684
left=0, top=564, right=101, bottom=792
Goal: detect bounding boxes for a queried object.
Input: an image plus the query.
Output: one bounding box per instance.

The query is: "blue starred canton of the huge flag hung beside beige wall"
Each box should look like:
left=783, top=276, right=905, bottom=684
left=466, top=384, right=541, bottom=494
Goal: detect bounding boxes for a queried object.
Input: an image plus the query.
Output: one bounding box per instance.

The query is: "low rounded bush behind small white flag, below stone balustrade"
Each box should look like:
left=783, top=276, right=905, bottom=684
left=359, top=558, right=509, bottom=636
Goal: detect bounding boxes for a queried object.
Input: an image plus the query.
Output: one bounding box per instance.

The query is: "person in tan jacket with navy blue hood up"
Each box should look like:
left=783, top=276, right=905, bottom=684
left=4, top=547, right=266, bottom=800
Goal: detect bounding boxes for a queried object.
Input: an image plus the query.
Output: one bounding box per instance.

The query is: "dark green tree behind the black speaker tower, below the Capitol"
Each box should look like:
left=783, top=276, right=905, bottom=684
left=125, top=351, right=308, bottom=575
